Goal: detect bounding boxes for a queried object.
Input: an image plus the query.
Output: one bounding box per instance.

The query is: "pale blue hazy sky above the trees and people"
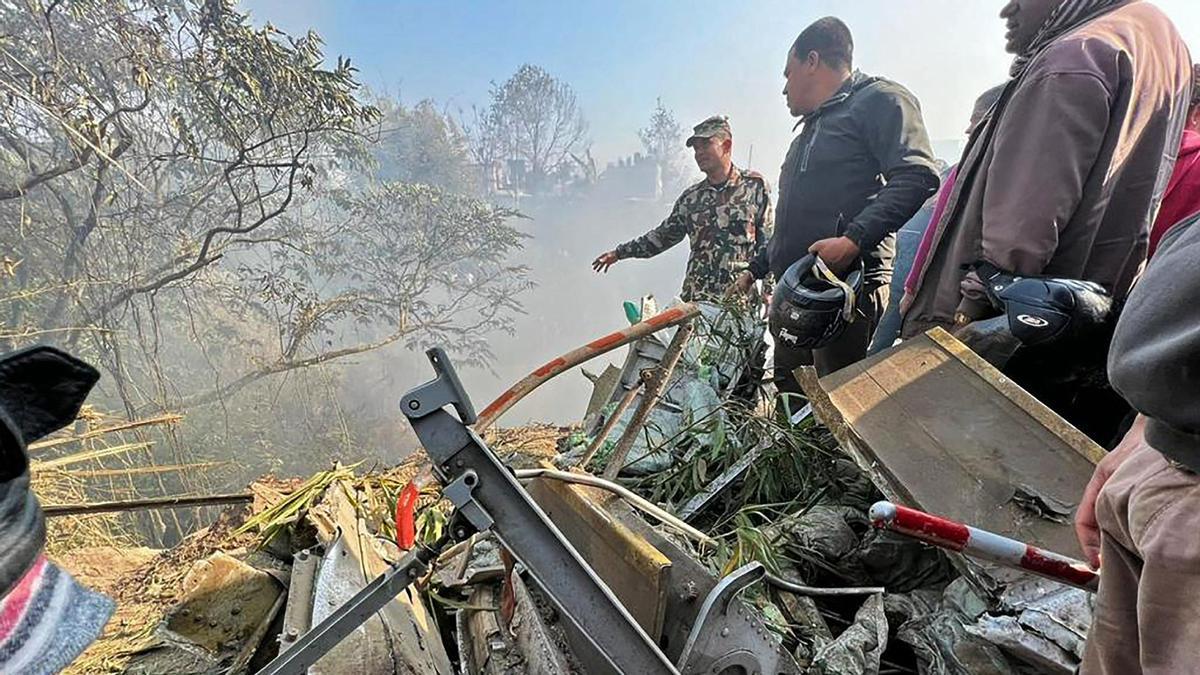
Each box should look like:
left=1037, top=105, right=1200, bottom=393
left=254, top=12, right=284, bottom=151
left=245, top=0, right=1200, bottom=180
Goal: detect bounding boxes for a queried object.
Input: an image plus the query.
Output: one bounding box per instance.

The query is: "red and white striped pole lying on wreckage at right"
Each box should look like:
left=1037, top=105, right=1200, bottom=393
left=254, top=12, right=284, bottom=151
left=869, top=502, right=1100, bottom=593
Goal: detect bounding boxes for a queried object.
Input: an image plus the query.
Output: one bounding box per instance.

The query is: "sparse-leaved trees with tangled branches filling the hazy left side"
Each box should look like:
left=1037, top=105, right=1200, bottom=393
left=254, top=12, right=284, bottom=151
left=0, top=0, right=535, bottom=475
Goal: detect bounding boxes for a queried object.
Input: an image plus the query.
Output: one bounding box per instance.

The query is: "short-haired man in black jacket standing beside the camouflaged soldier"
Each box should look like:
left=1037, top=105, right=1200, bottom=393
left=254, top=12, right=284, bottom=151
left=738, top=17, right=938, bottom=394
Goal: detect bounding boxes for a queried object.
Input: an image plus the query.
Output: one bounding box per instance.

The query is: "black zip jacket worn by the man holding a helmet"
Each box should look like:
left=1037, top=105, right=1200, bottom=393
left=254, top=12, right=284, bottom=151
left=750, top=71, right=938, bottom=283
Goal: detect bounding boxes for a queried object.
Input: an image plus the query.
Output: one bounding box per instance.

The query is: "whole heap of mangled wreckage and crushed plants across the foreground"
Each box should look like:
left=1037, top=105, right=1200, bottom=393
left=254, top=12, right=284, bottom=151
left=51, top=305, right=1091, bottom=675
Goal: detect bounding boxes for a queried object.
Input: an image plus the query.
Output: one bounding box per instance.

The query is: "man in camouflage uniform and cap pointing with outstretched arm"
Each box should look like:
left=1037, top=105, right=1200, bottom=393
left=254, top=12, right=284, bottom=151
left=592, top=117, right=774, bottom=301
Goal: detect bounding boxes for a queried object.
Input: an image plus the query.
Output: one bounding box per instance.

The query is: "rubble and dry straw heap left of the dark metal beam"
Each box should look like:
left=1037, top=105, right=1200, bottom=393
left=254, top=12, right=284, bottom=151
left=49, top=425, right=570, bottom=675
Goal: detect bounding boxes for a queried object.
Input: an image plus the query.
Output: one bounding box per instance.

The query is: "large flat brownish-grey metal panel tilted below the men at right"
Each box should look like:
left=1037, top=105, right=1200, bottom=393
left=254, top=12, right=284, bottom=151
left=798, top=329, right=1103, bottom=589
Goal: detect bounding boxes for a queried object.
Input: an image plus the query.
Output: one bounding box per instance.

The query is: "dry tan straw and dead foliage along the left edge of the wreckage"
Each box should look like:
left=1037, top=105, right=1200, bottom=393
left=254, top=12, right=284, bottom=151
left=49, top=424, right=571, bottom=675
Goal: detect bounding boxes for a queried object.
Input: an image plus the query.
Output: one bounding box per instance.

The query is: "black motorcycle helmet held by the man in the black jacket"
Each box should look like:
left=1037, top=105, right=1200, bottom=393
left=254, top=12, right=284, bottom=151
left=768, top=253, right=863, bottom=350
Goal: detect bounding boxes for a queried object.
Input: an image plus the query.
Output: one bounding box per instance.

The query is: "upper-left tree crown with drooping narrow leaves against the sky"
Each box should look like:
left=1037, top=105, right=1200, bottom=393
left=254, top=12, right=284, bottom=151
left=0, top=1, right=377, bottom=355
